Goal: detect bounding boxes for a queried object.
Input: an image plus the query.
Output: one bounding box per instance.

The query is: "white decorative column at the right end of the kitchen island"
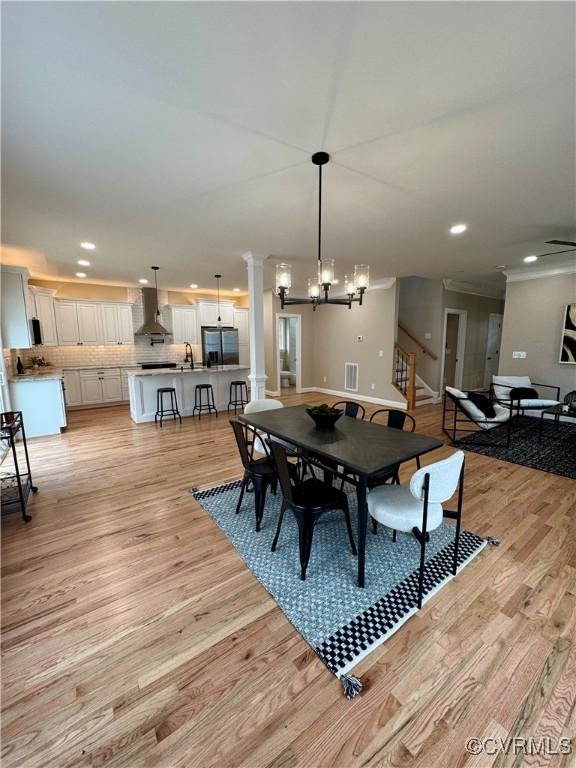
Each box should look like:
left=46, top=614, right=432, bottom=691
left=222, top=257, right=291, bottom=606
left=242, top=251, right=266, bottom=400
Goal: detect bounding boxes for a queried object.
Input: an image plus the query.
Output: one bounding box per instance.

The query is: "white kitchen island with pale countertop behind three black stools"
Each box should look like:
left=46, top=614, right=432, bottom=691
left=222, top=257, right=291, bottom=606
left=128, top=365, right=249, bottom=424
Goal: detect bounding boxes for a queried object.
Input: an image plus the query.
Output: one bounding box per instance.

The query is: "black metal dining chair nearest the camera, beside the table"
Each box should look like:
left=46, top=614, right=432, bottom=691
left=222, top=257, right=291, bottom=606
left=268, top=441, right=358, bottom=580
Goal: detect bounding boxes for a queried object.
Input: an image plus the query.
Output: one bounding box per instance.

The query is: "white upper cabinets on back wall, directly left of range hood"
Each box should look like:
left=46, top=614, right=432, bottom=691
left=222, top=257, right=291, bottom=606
left=54, top=299, right=134, bottom=346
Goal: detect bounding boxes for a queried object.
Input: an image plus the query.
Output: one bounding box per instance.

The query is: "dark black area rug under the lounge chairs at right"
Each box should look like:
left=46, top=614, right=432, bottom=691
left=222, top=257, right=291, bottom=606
left=459, top=416, right=576, bottom=479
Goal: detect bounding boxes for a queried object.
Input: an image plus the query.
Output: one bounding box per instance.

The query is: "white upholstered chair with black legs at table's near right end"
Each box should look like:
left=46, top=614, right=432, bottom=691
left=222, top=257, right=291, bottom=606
left=368, top=451, right=464, bottom=608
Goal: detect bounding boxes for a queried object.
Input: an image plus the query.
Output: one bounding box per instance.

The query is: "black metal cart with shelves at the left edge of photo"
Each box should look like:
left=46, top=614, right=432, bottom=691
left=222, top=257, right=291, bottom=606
left=0, top=411, right=38, bottom=523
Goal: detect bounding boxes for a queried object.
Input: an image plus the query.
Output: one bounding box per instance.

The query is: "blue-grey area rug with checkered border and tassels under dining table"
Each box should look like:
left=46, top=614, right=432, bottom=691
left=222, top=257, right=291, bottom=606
left=190, top=481, right=486, bottom=698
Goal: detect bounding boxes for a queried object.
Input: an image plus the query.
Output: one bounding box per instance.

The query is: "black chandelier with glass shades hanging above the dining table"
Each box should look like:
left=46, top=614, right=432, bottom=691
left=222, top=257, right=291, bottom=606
left=276, top=152, right=370, bottom=310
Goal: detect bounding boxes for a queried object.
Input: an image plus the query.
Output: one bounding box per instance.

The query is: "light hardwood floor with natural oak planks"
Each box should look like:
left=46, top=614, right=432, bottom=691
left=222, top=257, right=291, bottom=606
left=2, top=395, right=576, bottom=768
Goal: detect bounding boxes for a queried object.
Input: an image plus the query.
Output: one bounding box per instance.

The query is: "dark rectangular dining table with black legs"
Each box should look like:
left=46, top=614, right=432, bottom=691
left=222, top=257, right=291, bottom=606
left=238, top=405, right=443, bottom=587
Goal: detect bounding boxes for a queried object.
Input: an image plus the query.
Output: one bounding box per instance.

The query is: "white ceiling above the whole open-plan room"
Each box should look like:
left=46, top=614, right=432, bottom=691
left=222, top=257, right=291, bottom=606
left=2, top=2, right=576, bottom=288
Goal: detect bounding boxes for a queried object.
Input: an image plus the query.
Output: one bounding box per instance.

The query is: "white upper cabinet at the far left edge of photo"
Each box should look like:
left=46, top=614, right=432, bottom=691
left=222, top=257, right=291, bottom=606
left=1, top=266, right=32, bottom=349
